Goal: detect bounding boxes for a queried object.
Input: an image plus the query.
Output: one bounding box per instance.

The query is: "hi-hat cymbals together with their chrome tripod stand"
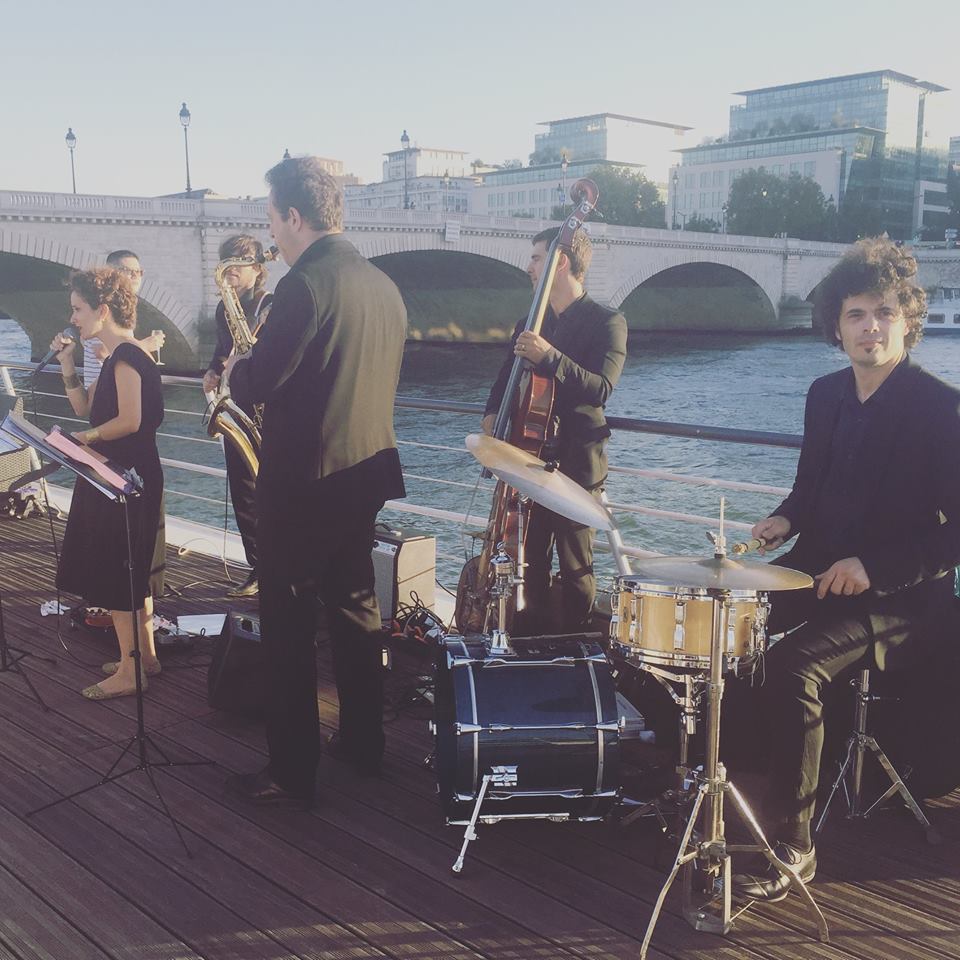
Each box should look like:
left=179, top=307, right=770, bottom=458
left=640, top=499, right=830, bottom=960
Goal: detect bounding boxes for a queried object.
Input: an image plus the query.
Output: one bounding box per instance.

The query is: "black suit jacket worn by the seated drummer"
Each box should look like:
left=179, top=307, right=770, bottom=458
left=773, top=356, right=960, bottom=617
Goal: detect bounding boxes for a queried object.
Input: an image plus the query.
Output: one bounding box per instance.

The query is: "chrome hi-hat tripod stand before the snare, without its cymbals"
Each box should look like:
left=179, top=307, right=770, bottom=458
left=640, top=576, right=830, bottom=960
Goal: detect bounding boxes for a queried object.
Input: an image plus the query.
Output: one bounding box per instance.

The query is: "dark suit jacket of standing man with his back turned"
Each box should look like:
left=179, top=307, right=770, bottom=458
left=230, top=233, right=407, bottom=501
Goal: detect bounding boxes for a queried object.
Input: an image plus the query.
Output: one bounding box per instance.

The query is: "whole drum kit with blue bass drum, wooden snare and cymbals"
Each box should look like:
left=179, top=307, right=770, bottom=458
left=431, top=435, right=828, bottom=958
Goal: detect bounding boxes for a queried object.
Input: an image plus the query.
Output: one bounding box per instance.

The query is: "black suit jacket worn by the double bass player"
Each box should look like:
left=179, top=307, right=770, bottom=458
left=486, top=294, right=627, bottom=490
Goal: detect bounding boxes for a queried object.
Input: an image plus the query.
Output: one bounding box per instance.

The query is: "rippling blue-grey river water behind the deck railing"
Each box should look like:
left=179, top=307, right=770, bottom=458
left=0, top=319, right=960, bottom=587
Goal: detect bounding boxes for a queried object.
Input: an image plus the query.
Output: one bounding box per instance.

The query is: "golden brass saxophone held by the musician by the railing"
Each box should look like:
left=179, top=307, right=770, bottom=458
left=207, top=247, right=279, bottom=477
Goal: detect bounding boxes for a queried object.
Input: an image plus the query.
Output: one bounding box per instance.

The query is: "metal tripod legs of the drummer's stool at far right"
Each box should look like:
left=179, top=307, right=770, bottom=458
left=814, top=667, right=942, bottom=844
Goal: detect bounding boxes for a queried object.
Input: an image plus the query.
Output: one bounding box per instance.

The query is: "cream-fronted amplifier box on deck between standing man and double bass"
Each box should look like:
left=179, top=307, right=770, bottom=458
left=372, top=524, right=437, bottom=620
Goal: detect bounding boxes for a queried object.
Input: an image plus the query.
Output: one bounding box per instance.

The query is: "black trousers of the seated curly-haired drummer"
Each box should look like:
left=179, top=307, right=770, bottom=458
left=762, top=590, right=921, bottom=838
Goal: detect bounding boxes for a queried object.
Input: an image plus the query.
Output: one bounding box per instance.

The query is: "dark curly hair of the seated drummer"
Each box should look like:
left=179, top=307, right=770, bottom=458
left=814, top=236, right=927, bottom=350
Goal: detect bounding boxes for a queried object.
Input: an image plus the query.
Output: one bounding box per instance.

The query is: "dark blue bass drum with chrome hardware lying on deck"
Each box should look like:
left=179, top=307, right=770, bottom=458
left=434, top=636, right=620, bottom=824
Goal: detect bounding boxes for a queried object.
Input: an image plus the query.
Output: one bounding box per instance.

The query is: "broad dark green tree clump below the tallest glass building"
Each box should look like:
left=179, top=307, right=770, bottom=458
left=727, top=167, right=836, bottom=240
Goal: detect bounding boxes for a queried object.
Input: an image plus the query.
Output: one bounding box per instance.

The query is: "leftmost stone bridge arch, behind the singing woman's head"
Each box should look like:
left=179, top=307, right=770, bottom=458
left=0, top=230, right=197, bottom=365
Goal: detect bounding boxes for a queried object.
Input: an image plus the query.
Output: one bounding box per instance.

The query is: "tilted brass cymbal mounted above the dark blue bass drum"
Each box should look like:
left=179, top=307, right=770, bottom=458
left=466, top=433, right=613, bottom=530
